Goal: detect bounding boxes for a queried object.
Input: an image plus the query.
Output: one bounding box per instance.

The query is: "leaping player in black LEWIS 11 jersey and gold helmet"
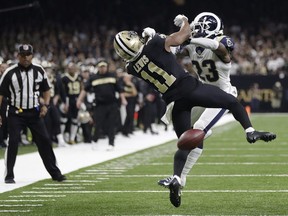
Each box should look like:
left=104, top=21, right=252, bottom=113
left=114, top=15, right=276, bottom=207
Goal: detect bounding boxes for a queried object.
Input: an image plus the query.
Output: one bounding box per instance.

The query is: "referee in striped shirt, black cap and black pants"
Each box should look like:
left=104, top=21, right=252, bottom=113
left=0, top=44, right=66, bottom=184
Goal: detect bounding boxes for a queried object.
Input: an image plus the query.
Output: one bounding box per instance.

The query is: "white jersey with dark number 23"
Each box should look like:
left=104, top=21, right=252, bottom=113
left=185, top=36, right=237, bottom=96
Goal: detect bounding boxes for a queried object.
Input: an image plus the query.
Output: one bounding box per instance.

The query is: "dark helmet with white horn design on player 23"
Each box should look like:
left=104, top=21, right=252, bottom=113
left=190, top=12, right=224, bottom=39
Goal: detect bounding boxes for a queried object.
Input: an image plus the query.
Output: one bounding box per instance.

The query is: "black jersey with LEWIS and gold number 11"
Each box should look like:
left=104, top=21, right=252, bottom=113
left=127, top=34, right=197, bottom=103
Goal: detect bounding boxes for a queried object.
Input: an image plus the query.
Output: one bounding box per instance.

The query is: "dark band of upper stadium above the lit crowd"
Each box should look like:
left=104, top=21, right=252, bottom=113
left=1, top=0, right=288, bottom=28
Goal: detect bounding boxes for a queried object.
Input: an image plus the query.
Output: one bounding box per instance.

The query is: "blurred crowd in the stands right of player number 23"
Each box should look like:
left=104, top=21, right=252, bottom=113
left=228, top=22, right=288, bottom=75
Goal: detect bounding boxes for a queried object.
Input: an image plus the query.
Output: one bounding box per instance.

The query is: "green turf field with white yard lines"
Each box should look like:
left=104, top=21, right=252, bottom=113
left=0, top=114, right=288, bottom=216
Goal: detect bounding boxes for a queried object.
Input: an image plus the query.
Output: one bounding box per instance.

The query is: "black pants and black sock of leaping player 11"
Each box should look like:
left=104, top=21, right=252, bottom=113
left=172, top=79, right=252, bottom=176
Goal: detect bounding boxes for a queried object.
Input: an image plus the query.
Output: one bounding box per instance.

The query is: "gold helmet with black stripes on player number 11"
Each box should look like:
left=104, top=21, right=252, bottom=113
left=114, top=31, right=144, bottom=62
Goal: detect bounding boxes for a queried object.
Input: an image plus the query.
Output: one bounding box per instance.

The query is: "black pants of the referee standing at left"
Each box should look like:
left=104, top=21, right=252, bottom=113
left=5, top=106, right=62, bottom=180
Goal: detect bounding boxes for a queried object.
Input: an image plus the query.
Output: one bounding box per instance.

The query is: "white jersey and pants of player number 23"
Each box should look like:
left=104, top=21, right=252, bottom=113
left=161, top=36, right=237, bottom=131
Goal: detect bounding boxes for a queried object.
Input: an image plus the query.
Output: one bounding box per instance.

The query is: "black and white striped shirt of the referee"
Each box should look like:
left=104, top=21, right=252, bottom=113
left=0, top=64, right=50, bottom=109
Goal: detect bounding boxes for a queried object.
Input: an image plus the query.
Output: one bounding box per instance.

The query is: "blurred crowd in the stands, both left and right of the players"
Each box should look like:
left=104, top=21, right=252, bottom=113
left=0, top=19, right=288, bottom=75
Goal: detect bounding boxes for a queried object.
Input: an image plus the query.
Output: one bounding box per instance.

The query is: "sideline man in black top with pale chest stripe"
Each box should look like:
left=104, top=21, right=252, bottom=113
left=76, top=59, right=127, bottom=150
